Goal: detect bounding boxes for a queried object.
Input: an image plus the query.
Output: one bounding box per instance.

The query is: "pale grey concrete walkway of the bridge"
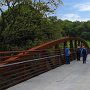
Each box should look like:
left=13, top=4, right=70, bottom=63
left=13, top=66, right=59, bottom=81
left=7, top=55, right=90, bottom=90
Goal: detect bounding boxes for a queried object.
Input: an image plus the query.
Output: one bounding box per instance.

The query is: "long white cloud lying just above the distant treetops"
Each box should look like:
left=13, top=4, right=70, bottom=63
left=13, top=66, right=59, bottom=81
left=57, top=13, right=90, bottom=21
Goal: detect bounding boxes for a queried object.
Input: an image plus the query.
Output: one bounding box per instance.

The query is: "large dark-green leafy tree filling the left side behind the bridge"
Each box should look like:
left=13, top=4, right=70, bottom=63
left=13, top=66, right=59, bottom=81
left=0, top=0, right=63, bottom=50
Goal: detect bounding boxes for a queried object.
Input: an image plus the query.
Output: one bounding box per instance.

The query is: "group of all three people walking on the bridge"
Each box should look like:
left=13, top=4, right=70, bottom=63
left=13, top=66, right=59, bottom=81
left=65, top=46, right=87, bottom=64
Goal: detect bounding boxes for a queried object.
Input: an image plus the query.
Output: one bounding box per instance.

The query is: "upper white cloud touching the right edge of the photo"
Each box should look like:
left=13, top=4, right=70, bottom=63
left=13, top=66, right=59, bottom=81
left=74, top=3, right=90, bottom=11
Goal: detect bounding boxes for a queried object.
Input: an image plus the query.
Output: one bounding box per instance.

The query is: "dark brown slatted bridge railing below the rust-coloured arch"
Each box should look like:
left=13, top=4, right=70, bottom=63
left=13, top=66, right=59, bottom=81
left=0, top=49, right=76, bottom=90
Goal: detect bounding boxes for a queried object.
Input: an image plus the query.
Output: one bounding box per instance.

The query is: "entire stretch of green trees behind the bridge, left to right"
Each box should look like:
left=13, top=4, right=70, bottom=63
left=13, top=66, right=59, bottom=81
left=0, top=0, right=90, bottom=51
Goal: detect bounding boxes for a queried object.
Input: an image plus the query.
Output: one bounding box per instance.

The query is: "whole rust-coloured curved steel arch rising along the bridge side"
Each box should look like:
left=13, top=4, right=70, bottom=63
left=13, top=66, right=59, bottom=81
left=2, top=37, right=89, bottom=64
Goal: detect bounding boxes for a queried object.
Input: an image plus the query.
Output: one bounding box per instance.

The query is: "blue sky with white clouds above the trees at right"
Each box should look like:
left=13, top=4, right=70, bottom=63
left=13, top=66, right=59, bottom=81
left=53, top=0, right=90, bottom=21
